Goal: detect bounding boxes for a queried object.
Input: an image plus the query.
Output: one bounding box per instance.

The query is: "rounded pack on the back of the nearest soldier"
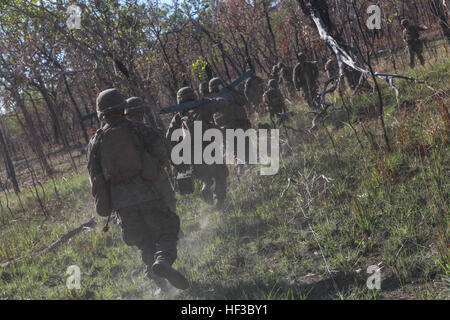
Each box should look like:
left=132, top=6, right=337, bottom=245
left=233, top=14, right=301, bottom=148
left=100, top=125, right=142, bottom=184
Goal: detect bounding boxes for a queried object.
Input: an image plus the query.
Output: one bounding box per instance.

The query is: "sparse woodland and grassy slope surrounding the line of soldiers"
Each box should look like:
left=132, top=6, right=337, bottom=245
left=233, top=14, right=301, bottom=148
left=0, top=0, right=450, bottom=299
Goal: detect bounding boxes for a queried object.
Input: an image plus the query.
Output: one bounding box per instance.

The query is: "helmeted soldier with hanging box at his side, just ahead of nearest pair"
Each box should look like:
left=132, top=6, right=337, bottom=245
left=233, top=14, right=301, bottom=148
left=166, top=87, right=228, bottom=208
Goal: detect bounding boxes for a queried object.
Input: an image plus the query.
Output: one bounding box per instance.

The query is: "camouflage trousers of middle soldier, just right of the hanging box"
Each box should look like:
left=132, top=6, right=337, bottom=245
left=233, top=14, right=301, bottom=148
left=193, top=164, right=228, bottom=203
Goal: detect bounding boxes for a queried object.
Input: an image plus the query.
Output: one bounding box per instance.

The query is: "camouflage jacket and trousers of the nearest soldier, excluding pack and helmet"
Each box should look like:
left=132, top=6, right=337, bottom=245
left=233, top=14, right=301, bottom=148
left=87, top=117, right=179, bottom=267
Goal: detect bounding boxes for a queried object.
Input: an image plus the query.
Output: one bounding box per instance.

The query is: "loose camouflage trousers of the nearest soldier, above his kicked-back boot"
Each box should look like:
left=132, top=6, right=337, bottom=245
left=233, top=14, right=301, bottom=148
left=119, top=201, right=180, bottom=267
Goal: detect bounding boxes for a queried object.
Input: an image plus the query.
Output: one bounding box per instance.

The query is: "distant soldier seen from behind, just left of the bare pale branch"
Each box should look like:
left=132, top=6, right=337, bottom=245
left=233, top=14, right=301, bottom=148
left=293, top=53, right=319, bottom=109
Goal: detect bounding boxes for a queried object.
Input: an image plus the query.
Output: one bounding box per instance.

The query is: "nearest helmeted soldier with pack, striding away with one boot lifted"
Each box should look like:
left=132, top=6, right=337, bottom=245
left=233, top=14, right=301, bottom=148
left=87, top=88, right=189, bottom=289
